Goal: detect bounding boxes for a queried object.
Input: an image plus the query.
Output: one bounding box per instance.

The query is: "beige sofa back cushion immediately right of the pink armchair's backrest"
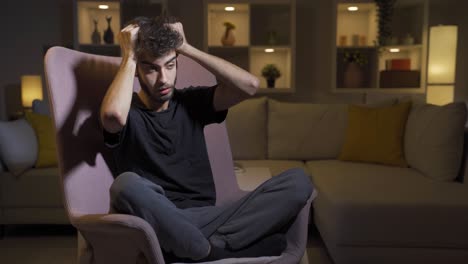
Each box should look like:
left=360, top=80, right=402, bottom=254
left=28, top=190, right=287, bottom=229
left=226, top=97, right=267, bottom=159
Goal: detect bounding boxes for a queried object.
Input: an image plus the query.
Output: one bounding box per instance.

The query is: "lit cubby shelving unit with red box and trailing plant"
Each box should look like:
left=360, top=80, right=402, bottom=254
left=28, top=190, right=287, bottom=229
left=333, top=0, right=428, bottom=93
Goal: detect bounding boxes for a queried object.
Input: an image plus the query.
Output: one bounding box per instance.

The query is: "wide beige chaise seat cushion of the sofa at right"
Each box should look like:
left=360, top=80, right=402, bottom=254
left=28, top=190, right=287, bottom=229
left=306, top=160, right=468, bottom=248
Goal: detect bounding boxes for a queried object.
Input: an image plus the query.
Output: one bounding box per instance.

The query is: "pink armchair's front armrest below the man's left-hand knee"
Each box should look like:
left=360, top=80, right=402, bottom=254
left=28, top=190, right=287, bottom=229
left=71, top=214, right=164, bottom=264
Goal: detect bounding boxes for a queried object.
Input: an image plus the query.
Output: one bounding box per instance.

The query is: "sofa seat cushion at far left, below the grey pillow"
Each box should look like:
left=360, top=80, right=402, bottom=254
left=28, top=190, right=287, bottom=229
left=0, top=168, right=63, bottom=208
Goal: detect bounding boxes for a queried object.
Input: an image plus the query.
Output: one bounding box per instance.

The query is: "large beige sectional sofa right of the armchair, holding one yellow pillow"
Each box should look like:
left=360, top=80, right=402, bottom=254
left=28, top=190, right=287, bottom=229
left=226, top=98, right=468, bottom=264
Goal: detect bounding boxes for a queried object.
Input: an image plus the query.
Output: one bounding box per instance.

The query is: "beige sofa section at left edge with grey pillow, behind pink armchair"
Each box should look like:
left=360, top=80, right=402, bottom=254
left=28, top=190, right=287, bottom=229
left=0, top=100, right=69, bottom=233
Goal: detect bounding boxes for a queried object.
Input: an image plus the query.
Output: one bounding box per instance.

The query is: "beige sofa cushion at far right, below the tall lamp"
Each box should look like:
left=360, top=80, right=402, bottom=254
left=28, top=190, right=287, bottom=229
left=405, top=103, right=466, bottom=181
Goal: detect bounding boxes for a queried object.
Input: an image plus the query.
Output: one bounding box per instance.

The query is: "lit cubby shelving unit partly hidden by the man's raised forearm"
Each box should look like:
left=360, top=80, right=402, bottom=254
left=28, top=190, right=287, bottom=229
left=204, top=0, right=295, bottom=93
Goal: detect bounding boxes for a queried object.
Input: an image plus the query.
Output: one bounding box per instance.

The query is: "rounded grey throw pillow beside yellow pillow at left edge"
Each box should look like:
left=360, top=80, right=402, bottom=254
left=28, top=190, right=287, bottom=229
left=0, top=119, right=38, bottom=176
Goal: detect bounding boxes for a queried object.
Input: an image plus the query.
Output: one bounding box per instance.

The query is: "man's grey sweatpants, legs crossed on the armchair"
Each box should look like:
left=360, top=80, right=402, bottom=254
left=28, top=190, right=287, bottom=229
left=110, top=169, right=312, bottom=260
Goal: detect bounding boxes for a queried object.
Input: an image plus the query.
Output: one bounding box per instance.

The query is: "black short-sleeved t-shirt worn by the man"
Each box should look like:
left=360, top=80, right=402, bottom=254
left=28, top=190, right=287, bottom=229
left=104, top=86, right=227, bottom=208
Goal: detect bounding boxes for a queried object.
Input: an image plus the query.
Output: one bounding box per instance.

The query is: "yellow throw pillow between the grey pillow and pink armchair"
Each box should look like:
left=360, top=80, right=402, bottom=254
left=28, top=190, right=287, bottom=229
left=26, top=112, right=57, bottom=168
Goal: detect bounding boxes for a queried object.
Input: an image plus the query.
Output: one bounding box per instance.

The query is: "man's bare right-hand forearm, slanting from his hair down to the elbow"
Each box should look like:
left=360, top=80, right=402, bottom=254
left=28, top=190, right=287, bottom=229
left=179, top=43, right=259, bottom=95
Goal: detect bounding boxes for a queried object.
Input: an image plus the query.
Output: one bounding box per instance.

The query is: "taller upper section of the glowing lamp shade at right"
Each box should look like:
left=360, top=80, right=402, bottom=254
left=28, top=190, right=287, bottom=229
left=427, top=26, right=458, bottom=84
